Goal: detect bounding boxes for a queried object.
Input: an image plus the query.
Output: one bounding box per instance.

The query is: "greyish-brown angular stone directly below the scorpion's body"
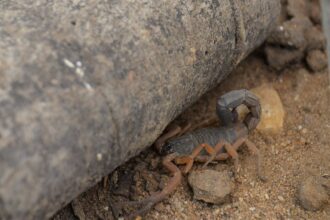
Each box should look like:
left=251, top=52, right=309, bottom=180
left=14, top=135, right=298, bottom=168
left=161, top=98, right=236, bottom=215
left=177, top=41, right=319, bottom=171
left=188, top=170, right=233, bottom=204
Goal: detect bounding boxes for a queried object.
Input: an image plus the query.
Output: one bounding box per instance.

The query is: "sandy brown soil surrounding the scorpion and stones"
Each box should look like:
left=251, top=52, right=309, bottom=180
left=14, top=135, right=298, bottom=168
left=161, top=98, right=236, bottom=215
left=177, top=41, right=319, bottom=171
left=53, top=1, right=330, bottom=220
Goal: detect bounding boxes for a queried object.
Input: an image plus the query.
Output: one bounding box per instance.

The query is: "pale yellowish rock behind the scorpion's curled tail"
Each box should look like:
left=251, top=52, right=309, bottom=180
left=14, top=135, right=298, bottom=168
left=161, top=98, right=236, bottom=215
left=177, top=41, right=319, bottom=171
left=237, top=84, right=285, bottom=134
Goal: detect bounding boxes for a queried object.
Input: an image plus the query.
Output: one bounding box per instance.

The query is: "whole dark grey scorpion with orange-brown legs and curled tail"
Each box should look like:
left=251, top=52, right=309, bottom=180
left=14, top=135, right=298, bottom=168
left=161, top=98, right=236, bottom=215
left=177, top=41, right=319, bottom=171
left=118, top=89, right=266, bottom=219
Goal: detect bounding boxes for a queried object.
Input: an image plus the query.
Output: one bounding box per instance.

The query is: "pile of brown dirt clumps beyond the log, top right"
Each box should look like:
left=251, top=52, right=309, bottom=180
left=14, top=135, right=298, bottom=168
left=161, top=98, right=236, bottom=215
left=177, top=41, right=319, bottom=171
left=265, top=0, right=327, bottom=72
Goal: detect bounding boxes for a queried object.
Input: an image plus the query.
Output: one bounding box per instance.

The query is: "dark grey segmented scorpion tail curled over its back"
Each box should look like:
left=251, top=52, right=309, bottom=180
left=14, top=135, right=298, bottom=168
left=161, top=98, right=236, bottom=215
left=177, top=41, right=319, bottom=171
left=216, top=89, right=261, bottom=131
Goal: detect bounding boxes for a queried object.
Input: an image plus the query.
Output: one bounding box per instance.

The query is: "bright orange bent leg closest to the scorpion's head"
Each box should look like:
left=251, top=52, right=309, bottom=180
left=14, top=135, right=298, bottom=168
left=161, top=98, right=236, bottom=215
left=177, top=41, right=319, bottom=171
left=175, top=143, right=215, bottom=173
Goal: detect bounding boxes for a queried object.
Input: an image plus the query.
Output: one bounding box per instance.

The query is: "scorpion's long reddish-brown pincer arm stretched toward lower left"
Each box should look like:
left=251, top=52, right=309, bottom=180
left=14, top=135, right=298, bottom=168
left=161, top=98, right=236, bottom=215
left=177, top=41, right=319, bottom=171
left=121, top=153, right=182, bottom=219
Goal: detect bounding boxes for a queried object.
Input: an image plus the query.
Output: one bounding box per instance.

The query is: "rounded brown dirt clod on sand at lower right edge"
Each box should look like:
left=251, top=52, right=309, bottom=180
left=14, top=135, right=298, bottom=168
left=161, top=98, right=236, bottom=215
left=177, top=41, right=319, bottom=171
left=298, top=176, right=329, bottom=211
